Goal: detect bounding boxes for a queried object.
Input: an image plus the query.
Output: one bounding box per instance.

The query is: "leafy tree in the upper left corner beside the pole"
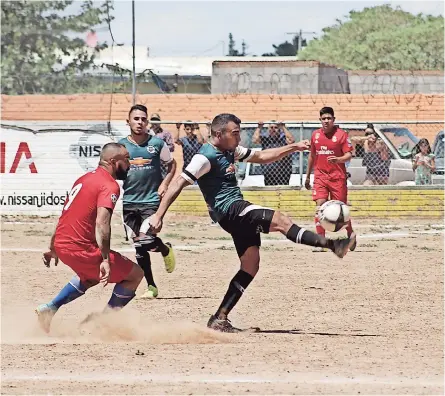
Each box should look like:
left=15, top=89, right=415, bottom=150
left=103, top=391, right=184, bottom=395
left=1, top=0, right=112, bottom=94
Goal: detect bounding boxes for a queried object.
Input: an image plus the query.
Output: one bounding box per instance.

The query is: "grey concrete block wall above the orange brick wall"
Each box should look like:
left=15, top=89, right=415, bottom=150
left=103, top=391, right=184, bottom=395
left=212, top=59, right=444, bottom=95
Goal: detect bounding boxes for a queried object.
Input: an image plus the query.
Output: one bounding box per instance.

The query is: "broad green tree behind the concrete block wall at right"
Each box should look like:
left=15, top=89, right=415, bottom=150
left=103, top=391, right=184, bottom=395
left=299, top=5, right=444, bottom=70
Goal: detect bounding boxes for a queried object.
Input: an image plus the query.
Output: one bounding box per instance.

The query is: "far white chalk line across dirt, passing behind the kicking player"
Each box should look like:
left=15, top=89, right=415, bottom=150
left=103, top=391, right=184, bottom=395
left=0, top=230, right=444, bottom=253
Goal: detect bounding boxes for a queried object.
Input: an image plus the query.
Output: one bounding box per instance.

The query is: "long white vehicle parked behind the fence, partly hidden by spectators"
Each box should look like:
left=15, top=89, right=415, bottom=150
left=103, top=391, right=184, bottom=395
left=238, top=123, right=419, bottom=186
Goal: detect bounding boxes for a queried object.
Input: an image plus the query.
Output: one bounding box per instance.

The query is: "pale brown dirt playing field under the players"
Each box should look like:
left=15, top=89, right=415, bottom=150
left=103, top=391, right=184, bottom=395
left=1, top=217, right=444, bottom=395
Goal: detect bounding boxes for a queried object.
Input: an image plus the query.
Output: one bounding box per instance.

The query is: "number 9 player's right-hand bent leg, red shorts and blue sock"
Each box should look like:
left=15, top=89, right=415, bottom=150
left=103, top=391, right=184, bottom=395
left=105, top=250, right=144, bottom=310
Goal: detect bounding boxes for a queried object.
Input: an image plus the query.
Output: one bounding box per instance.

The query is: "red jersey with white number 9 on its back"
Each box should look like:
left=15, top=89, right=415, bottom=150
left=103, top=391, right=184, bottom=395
left=54, top=167, right=120, bottom=250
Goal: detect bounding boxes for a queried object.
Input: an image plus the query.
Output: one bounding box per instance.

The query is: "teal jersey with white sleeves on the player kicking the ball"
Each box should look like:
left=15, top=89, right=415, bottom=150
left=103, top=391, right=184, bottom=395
left=182, top=143, right=253, bottom=219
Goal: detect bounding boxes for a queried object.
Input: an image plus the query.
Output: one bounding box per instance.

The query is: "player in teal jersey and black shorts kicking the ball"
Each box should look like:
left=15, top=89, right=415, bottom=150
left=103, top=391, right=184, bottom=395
left=149, top=114, right=355, bottom=333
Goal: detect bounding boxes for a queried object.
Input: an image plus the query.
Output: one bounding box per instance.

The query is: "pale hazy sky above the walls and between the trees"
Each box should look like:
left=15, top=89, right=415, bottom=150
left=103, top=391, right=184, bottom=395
left=72, top=0, right=444, bottom=56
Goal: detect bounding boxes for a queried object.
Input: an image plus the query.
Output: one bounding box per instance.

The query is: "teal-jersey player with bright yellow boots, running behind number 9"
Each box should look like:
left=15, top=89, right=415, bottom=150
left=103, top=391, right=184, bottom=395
left=119, top=105, right=176, bottom=298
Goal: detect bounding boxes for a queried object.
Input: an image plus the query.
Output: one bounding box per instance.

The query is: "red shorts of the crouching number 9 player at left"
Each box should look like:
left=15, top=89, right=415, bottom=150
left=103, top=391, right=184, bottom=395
left=56, top=246, right=133, bottom=283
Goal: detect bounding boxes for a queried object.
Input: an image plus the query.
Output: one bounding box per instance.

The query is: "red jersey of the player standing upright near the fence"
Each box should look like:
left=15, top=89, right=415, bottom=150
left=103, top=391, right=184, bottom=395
left=311, top=127, right=352, bottom=180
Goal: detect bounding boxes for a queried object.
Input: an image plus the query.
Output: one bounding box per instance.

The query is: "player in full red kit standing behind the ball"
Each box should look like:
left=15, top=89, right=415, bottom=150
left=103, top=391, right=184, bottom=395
left=305, top=107, right=357, bottom=250
